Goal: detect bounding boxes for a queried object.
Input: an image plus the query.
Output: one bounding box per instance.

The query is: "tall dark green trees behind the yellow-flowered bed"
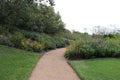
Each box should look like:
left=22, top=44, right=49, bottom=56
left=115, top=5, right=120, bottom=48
left=0, top=0, right=64, bottom=34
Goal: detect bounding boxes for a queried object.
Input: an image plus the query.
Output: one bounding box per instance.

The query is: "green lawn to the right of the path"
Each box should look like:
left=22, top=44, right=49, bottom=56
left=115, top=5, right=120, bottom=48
left=69, top=58, right=120, bottom=80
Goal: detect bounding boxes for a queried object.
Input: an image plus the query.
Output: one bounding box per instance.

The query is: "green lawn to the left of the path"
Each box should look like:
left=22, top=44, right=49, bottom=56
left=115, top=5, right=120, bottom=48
left=0, top=45, right=40, bottom=80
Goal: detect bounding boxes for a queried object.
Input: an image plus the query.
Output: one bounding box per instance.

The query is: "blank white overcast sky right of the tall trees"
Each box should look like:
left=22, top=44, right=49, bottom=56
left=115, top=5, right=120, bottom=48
left=54, top=0, right=120, bottom=33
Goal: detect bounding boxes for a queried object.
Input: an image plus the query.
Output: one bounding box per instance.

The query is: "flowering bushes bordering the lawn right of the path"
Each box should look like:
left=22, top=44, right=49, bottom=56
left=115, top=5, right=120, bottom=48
left=65, top=38, right=120, bottom=59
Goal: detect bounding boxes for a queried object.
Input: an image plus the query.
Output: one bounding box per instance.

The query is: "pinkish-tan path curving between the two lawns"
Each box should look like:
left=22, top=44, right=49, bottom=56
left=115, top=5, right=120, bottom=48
left=29, top=48, right=80, bottom=80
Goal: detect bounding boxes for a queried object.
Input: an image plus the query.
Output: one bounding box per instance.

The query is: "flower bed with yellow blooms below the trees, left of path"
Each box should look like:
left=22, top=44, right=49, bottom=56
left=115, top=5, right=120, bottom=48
left=0, top=31, right=69, bottom=52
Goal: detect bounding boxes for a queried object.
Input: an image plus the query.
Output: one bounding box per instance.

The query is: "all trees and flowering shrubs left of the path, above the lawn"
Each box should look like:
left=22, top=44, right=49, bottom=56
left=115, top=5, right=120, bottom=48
left=0, top=0, right=69, bottom=52
